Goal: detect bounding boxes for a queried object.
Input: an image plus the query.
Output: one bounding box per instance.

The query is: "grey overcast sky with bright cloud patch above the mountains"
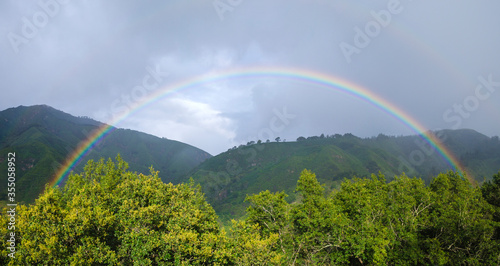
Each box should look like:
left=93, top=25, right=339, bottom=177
left=0, top=0, right=500, bottom=155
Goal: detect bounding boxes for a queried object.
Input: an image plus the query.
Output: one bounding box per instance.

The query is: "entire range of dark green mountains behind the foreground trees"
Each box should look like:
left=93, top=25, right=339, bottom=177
left=0, top=105, right=500, bottom=221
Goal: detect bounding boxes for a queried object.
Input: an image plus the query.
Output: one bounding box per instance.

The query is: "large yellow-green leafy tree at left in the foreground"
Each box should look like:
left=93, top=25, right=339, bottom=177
left=5, top=156, right=232, bottom=265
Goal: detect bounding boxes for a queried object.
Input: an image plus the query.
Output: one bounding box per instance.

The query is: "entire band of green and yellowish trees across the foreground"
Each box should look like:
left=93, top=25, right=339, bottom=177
left=0, top=157, right=500, bottom=265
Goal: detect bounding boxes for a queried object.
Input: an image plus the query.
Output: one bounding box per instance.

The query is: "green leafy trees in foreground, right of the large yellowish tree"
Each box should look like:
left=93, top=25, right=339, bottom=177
left=246, top=170, right=500, bottom=265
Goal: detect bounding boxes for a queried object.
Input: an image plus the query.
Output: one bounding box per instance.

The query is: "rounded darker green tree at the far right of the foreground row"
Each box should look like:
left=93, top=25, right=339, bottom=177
left=422, top=172, right=500, bottom=265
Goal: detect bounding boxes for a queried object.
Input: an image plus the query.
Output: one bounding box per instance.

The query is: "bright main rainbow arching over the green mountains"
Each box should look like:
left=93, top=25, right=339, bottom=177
left=49, top=66, right=466, bottom=186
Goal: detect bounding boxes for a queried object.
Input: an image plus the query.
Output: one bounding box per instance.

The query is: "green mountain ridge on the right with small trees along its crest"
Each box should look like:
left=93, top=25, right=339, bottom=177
left=190, top=130, right=500, bottom=220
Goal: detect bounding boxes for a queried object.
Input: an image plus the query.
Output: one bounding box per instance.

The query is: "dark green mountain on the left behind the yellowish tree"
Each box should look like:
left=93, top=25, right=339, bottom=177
left=0, top=105, right=211, bottom=202
